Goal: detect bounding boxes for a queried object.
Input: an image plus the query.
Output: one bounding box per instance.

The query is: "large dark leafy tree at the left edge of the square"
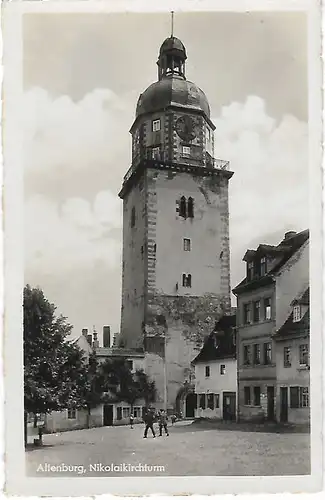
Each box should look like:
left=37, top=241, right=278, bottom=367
left=23, top=285, right=93, bottom=442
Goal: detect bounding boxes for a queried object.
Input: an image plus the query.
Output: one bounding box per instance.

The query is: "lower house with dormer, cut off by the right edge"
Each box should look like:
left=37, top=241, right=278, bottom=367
left=273, top=288, right=310, bottom=424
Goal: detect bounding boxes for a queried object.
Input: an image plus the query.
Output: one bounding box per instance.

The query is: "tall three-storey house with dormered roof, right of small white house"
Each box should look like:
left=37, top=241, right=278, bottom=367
left=233, top=230, right=309, bottom=420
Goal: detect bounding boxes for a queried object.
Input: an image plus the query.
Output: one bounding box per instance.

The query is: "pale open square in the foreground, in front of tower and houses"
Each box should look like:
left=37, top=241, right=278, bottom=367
left=26, top=422, right=310, bottom=477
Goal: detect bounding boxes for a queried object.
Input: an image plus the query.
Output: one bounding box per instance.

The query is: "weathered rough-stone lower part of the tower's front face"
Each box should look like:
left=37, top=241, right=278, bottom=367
left=144, top=294, right=230, bottom=410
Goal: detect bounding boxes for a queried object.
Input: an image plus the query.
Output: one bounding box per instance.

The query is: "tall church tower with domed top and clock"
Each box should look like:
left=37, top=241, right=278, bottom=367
left=119, top=32, right=233, bottom=416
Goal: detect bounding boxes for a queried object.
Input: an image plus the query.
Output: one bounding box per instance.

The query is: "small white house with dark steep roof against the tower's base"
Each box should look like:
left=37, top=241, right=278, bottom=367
left=193, top=315, right=237, bottom=420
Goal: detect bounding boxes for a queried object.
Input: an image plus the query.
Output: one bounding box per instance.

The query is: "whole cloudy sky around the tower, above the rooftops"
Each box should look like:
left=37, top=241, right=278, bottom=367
left=22, top=12, right=308, bottom=342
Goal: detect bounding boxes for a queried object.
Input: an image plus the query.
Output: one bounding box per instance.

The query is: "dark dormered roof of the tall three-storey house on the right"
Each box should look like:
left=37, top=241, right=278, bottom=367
left=233, top=229, right=309, bottom=295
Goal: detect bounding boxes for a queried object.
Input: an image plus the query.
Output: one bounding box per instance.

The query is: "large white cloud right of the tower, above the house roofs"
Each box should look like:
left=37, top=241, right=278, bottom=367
left=214, top=96, right=308, bottom=285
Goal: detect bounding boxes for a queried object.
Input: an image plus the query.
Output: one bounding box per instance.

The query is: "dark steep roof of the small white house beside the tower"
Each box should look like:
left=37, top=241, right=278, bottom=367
left=192, top=315, right=236, bottom=364
